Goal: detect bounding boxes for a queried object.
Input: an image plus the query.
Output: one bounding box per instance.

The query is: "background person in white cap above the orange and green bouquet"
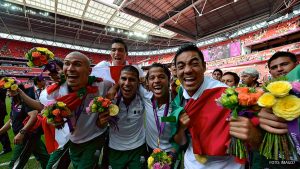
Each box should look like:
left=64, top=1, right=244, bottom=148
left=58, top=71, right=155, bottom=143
left=241, top=68, right=259, bottom=88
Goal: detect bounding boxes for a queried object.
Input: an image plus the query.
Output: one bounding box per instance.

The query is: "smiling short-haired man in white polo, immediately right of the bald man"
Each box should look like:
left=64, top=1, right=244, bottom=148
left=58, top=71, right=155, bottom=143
left=109, top=65, right=146, bottom=169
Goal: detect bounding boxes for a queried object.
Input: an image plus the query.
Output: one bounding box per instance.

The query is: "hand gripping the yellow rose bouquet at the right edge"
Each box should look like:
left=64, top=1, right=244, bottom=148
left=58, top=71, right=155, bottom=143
left=258, top=108, right=288, bottom=134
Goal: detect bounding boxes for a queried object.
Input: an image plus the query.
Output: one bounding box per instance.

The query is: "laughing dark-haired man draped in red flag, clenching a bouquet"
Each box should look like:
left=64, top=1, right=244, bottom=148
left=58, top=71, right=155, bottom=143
left=172, top=45, right=257, bottom=169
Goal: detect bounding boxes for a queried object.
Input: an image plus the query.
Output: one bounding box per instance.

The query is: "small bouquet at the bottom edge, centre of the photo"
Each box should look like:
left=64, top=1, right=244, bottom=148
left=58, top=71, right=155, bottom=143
left=147, top=148, right=172, bottom=169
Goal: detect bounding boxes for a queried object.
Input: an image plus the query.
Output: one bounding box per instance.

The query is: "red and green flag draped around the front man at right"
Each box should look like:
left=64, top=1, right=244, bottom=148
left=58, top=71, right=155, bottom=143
left=171, top=84, right=230, bottom=156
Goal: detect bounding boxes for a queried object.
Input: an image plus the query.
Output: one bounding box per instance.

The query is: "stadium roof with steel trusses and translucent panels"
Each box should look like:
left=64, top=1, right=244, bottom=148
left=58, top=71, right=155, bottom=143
left=0, top=0, right=299, bottom=51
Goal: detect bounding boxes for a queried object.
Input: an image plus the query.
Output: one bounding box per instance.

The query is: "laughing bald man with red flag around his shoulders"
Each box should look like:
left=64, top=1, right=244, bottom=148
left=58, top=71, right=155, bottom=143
left=41, top=52, right=112, bottom=169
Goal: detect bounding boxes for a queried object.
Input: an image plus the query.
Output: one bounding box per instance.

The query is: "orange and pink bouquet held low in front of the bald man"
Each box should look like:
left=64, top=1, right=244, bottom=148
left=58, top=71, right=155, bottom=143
left=42, top=102, right=72, bottom=128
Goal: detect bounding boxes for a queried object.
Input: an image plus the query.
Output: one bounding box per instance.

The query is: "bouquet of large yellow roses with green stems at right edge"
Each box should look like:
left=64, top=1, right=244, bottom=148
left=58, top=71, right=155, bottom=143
left=258, top=78, right=300, bottom=161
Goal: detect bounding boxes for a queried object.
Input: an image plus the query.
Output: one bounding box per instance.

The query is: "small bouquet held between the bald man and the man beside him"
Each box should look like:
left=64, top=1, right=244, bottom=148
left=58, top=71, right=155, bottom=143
left=86, top=96, right=119, bottom=130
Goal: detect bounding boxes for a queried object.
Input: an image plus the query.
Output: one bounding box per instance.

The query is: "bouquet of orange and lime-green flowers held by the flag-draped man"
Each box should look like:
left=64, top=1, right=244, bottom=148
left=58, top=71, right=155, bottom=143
left=216, top=87, right=263, bottom=162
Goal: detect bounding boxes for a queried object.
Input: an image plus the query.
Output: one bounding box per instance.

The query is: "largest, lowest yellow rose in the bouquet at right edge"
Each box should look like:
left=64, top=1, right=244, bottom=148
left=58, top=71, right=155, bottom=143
left=272, top=95, right=300, bottom=121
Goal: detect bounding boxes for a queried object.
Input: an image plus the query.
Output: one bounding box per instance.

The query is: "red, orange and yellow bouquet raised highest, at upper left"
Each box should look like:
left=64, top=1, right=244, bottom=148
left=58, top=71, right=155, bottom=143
left=25, top=47, right=54, bottom=67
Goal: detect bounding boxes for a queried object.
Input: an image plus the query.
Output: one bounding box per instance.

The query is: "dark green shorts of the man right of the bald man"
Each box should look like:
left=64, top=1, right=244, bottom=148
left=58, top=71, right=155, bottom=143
left=109, top=144, right=147, bottom=169
